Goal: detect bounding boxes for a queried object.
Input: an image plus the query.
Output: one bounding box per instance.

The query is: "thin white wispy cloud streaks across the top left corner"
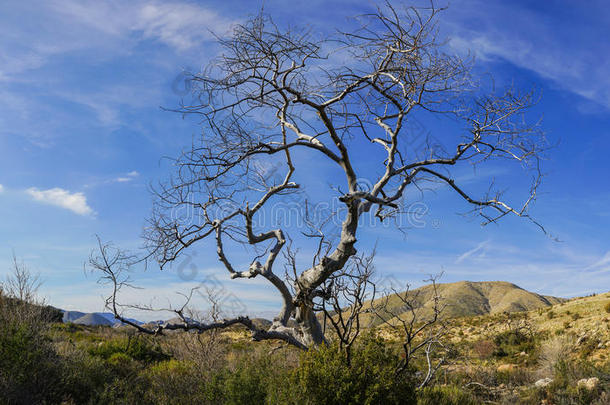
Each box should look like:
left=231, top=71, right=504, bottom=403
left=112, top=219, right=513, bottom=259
left=0, top=0, right=234, bottom=74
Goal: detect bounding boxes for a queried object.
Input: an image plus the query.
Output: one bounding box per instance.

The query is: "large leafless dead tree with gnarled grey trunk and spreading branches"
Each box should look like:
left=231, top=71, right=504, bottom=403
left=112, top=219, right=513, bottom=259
left=96, top=2, right=546, bottom=347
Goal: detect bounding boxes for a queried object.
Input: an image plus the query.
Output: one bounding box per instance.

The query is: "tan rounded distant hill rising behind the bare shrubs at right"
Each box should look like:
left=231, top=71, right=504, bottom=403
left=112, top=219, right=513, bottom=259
left=356, top=281, right=566, bottom=324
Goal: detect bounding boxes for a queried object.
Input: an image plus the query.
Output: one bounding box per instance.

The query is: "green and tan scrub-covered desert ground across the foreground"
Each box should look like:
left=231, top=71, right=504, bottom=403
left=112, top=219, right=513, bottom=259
left=0, top=256, right=610, bottom=405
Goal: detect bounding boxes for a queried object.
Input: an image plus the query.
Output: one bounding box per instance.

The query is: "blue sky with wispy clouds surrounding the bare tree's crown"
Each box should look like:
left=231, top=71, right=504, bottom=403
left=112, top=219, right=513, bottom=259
left=0, top=0, right=610, bottom=314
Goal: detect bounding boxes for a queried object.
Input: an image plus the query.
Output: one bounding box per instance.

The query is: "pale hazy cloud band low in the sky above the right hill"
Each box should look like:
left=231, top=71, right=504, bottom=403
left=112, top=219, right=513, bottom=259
left=375, top=241, right=610, bottom=297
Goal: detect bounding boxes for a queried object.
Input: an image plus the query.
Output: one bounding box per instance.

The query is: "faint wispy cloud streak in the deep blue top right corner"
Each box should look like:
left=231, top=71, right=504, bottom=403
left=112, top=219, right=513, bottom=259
left=444, top=0, right=610, bottom=108
